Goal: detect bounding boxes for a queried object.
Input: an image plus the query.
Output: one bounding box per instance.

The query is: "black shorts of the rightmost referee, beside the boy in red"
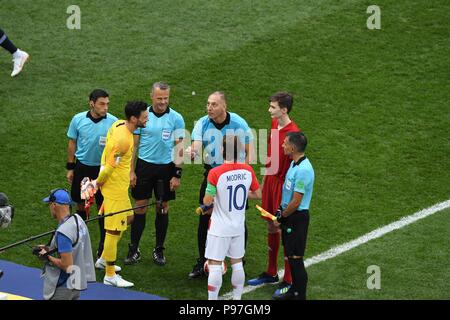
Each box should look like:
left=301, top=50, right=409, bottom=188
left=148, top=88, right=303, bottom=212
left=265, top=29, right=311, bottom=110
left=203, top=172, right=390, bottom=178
left=281, top=210, right=309, bottom=257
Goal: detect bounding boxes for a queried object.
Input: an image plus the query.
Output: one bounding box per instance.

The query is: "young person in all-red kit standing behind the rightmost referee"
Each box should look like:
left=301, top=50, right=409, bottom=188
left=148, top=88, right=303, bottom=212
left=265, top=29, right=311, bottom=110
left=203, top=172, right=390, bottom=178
left=247, top=92, right=300, bottom=297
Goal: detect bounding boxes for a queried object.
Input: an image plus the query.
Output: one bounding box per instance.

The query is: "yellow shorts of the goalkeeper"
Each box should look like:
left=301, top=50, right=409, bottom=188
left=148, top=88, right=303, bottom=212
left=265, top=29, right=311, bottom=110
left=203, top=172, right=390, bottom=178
left=103, top=197, right=134, bottom=231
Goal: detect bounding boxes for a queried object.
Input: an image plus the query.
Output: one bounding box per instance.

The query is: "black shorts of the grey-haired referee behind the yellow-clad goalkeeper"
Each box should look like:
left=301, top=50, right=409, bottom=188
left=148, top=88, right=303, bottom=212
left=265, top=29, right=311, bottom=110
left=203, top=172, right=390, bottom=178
left=131, top=159, right=175, bottom=201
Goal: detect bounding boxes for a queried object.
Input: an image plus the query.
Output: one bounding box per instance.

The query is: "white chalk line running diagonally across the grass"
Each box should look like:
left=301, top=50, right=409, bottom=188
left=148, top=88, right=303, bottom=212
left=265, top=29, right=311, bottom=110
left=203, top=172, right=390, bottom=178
left=222, top=199, right=450, bottom=300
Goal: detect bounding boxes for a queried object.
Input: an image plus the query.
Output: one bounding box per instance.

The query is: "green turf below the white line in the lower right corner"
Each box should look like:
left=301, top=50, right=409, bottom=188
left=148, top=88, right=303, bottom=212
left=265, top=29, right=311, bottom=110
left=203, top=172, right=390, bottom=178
left=245, top=209, right=450, bottom=300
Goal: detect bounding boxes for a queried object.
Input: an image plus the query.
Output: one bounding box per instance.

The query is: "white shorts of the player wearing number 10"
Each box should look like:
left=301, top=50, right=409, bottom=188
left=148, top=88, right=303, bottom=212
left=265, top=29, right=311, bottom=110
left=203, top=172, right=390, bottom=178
left=205, top=233, right=245, bottom=261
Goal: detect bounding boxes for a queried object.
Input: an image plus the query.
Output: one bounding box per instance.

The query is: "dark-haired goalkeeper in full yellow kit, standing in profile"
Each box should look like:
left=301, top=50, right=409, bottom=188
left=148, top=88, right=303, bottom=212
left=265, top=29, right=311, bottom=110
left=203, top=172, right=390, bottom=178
left=94, top=101, right=148, bottom=287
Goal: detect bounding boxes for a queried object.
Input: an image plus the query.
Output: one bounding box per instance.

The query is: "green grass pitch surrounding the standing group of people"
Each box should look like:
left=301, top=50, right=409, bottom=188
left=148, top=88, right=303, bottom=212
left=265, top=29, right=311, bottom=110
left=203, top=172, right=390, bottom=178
left=0, top=0, right=450, bottom=299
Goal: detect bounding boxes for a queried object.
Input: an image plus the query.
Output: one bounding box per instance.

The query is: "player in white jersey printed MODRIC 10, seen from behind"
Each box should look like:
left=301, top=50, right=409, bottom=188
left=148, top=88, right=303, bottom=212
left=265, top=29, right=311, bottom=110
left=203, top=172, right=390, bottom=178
left=203, top=136, right=261, bottom=300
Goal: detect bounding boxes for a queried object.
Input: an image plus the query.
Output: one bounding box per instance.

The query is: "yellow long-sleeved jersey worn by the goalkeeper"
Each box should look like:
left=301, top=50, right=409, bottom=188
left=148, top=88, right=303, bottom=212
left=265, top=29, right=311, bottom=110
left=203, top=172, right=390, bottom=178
left=97, top=120, right=134, bottom=200
